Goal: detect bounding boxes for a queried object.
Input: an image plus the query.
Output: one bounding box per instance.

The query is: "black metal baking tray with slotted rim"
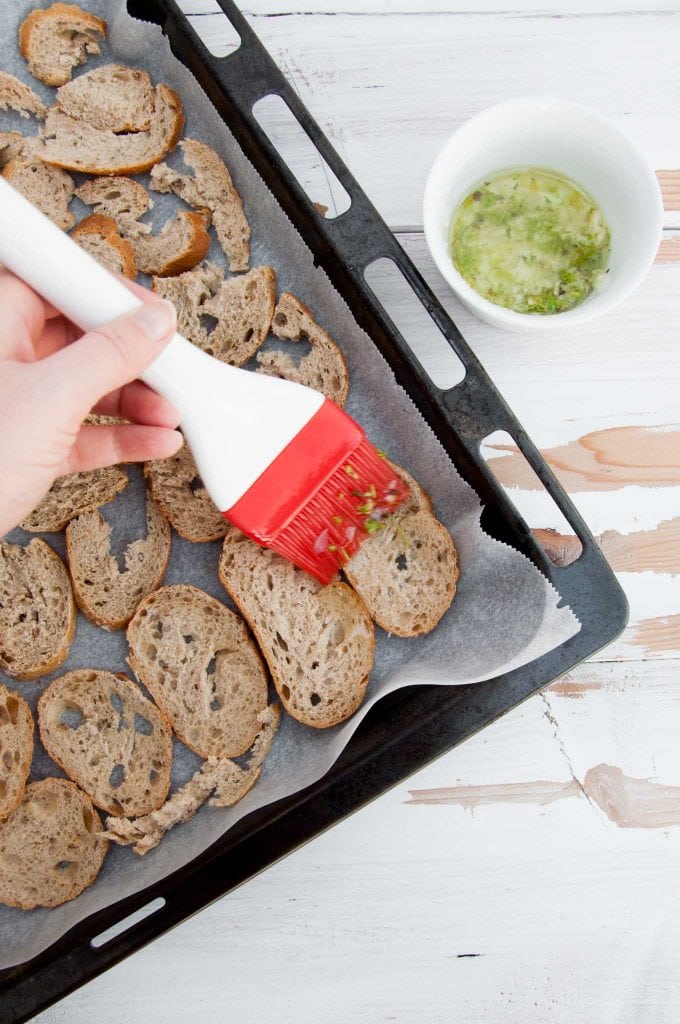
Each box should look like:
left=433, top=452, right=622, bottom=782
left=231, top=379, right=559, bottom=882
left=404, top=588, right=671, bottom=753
left=0, top=0, right=628, bottom=1024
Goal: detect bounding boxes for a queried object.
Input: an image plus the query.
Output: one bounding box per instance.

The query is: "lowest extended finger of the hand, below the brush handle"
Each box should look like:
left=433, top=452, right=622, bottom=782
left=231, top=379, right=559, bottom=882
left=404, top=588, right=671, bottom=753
left=61, top=424, right=183, bottom=474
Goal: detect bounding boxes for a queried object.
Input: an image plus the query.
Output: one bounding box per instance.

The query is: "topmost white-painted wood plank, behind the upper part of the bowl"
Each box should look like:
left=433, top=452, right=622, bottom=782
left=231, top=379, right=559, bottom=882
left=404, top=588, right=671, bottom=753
left=182, top=4, right=680, bottom=226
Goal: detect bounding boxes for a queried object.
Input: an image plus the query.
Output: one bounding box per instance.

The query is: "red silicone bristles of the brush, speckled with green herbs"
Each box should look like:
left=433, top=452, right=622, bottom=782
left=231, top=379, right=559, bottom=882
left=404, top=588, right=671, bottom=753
left=269, top=439, right=410, bottom=584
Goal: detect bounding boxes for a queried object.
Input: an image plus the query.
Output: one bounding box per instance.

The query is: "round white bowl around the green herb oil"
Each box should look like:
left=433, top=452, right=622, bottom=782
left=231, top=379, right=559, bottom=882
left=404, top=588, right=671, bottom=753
left=423, top=96, right=664, bottom=331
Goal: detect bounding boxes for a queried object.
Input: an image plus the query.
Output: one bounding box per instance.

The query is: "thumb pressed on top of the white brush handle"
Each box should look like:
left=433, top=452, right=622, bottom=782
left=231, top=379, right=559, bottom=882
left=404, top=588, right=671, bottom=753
left=37, top=299, right=176, bottom=419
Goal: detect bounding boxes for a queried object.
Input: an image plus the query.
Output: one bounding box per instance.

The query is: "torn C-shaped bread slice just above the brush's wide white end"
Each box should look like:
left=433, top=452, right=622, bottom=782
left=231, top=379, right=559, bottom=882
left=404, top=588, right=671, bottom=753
left=257, top=292, right=349, bottom=406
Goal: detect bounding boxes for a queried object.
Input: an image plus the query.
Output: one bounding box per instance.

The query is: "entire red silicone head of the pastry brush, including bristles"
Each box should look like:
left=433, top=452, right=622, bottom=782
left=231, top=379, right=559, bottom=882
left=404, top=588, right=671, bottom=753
left=224, top=400, right=410, bottom=584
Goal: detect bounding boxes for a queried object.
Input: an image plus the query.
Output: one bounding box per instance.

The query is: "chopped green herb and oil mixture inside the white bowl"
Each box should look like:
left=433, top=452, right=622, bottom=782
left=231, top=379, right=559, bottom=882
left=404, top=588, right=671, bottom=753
left=451, top=169, right=609, bottom=314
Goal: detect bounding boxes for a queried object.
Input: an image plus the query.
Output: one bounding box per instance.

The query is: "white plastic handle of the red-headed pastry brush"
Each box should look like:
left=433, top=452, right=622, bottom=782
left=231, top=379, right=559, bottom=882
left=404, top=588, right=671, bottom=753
left=0, top=178, right=324, bottom=511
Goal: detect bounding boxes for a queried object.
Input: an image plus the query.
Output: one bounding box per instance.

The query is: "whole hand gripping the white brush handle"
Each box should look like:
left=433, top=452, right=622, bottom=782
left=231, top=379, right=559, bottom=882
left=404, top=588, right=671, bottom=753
left=0, top=268, right=182, bottom=537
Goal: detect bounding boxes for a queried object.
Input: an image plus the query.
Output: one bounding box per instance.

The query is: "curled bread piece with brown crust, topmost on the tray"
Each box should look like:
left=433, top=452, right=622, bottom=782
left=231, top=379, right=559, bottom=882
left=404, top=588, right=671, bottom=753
left=18, top=3, right=107, bottom=85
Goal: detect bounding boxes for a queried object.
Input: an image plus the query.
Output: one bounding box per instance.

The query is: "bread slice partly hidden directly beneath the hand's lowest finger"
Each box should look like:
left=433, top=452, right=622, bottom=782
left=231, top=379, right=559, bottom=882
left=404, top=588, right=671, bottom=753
left=22, top=466, right=128, bottom=534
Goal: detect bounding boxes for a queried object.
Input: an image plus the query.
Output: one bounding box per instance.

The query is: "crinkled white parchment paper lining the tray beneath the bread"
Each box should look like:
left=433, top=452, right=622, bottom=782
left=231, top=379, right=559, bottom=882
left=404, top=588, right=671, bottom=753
left=0, top=0, right=580, bottom=968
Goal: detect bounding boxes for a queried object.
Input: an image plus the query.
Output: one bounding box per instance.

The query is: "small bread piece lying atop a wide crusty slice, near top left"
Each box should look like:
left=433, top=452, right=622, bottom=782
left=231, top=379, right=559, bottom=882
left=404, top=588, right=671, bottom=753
left=56, top=65, right=156, bottom=133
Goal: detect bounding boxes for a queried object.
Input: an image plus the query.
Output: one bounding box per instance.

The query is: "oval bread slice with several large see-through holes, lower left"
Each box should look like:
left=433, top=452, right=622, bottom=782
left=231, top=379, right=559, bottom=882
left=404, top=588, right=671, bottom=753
left=38, top=669, right=172, bottom=817
